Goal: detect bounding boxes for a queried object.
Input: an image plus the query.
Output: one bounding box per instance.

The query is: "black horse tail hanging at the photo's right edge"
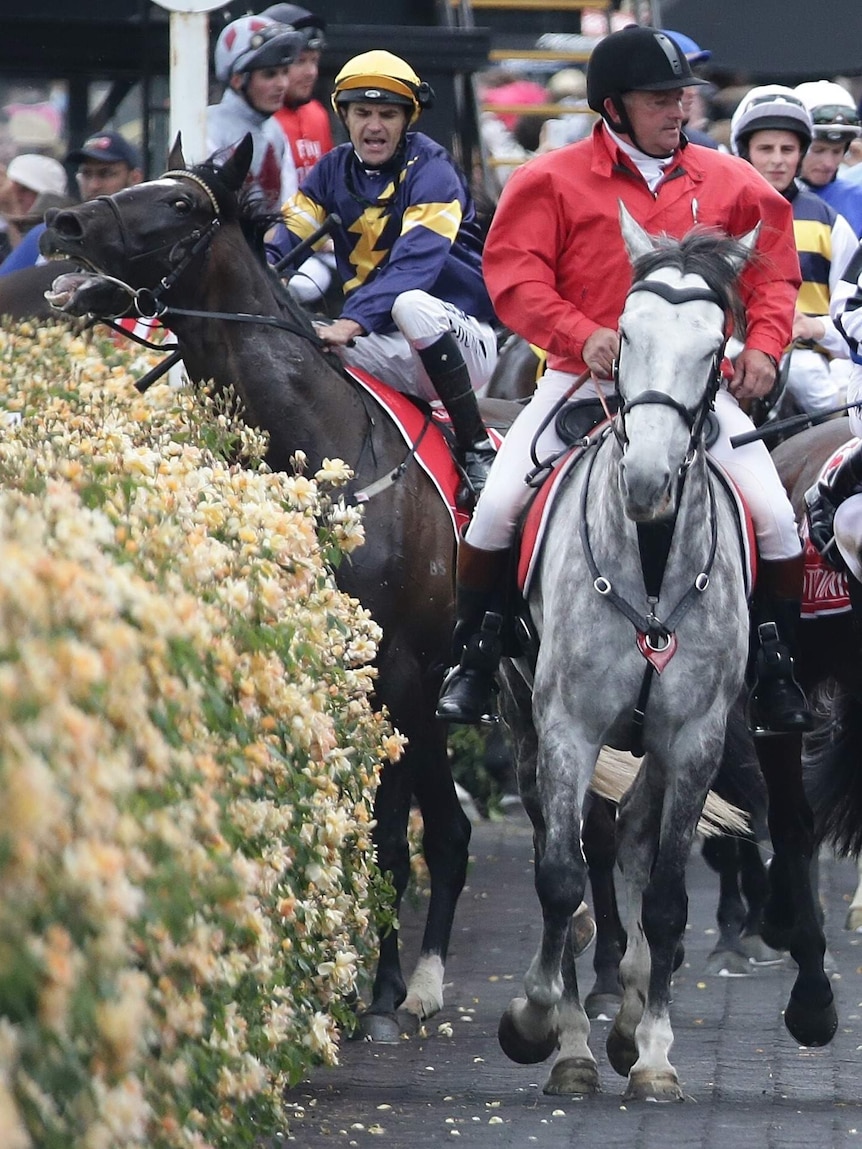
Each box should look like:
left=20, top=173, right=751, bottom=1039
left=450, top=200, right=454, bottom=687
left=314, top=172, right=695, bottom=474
left=803, top=685, right=862, bottom=858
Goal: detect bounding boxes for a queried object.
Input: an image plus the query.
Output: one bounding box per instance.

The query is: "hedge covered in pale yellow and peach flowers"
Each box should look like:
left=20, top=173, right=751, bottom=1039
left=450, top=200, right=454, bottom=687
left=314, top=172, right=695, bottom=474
left=0, top=325, right=401, bottom=1149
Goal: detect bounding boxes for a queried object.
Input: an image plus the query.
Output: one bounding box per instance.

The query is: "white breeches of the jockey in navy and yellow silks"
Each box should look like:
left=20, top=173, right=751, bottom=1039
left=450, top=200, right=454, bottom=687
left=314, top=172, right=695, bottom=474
left=339, top=291, right=497, bottom=402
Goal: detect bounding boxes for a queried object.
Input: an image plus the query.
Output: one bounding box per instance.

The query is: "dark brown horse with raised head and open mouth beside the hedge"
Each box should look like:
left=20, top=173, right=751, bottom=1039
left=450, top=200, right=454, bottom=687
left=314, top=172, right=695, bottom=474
left=43, top=138, right=517, bottom=1041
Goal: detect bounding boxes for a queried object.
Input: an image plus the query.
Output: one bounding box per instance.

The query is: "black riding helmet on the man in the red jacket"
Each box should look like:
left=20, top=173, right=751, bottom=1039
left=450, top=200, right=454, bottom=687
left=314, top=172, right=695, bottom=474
left=586, top=24, right=708, bottom=155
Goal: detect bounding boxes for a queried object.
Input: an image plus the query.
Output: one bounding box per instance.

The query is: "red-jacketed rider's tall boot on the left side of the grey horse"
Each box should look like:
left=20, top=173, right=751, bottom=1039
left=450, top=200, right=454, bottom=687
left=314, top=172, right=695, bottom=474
left=437, top=539, right=509, bottom=726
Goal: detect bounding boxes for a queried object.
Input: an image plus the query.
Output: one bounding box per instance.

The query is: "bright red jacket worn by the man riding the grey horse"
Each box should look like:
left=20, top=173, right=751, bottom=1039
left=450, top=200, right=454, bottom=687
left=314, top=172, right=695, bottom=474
left=483, top=123, right=801, bottom=375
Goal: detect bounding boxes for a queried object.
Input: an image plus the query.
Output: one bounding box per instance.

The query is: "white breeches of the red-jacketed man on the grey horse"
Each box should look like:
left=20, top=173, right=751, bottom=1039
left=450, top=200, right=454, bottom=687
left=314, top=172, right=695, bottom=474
left=465, top=371, right=801, bottom=561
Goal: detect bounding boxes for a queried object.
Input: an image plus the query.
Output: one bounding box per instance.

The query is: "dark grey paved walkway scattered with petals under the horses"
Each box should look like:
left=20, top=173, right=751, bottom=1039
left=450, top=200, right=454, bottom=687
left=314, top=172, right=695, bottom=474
left=287, top=815, right=862, bottom=1149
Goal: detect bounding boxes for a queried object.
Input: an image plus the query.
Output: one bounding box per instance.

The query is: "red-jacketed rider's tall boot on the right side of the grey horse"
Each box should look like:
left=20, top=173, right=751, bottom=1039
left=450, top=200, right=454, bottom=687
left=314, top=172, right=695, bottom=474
left=748, top=555, right=814, bottom=737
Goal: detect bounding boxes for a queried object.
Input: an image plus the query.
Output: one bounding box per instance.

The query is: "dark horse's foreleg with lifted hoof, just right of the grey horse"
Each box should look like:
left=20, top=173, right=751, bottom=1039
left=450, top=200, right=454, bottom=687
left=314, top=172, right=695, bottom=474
left=756, top=735, right=838, bottom=1046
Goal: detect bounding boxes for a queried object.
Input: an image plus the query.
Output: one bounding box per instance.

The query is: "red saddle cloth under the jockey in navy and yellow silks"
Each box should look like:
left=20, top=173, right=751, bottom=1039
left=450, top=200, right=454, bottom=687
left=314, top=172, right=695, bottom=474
left=345, top=365, right=502, bottom=537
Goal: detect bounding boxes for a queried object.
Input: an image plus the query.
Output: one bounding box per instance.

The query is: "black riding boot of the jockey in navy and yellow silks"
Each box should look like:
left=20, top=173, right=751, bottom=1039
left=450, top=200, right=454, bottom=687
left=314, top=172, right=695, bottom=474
left=416, top=331, right=497, bottom=499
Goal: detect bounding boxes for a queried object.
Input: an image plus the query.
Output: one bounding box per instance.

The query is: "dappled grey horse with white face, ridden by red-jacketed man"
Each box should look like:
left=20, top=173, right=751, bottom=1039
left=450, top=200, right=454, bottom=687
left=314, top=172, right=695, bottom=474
left=500, top=208, right=754, bottom=1100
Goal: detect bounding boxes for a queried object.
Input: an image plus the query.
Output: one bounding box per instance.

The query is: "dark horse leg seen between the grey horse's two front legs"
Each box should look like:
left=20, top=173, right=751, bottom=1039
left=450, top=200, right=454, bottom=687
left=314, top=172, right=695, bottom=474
left=583, top=795, right=625, bottom=1020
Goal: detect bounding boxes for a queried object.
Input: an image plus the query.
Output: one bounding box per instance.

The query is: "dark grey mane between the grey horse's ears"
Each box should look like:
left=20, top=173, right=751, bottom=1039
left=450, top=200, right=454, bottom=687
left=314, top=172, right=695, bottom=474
left=632, top=228, right=753, bottom=336
